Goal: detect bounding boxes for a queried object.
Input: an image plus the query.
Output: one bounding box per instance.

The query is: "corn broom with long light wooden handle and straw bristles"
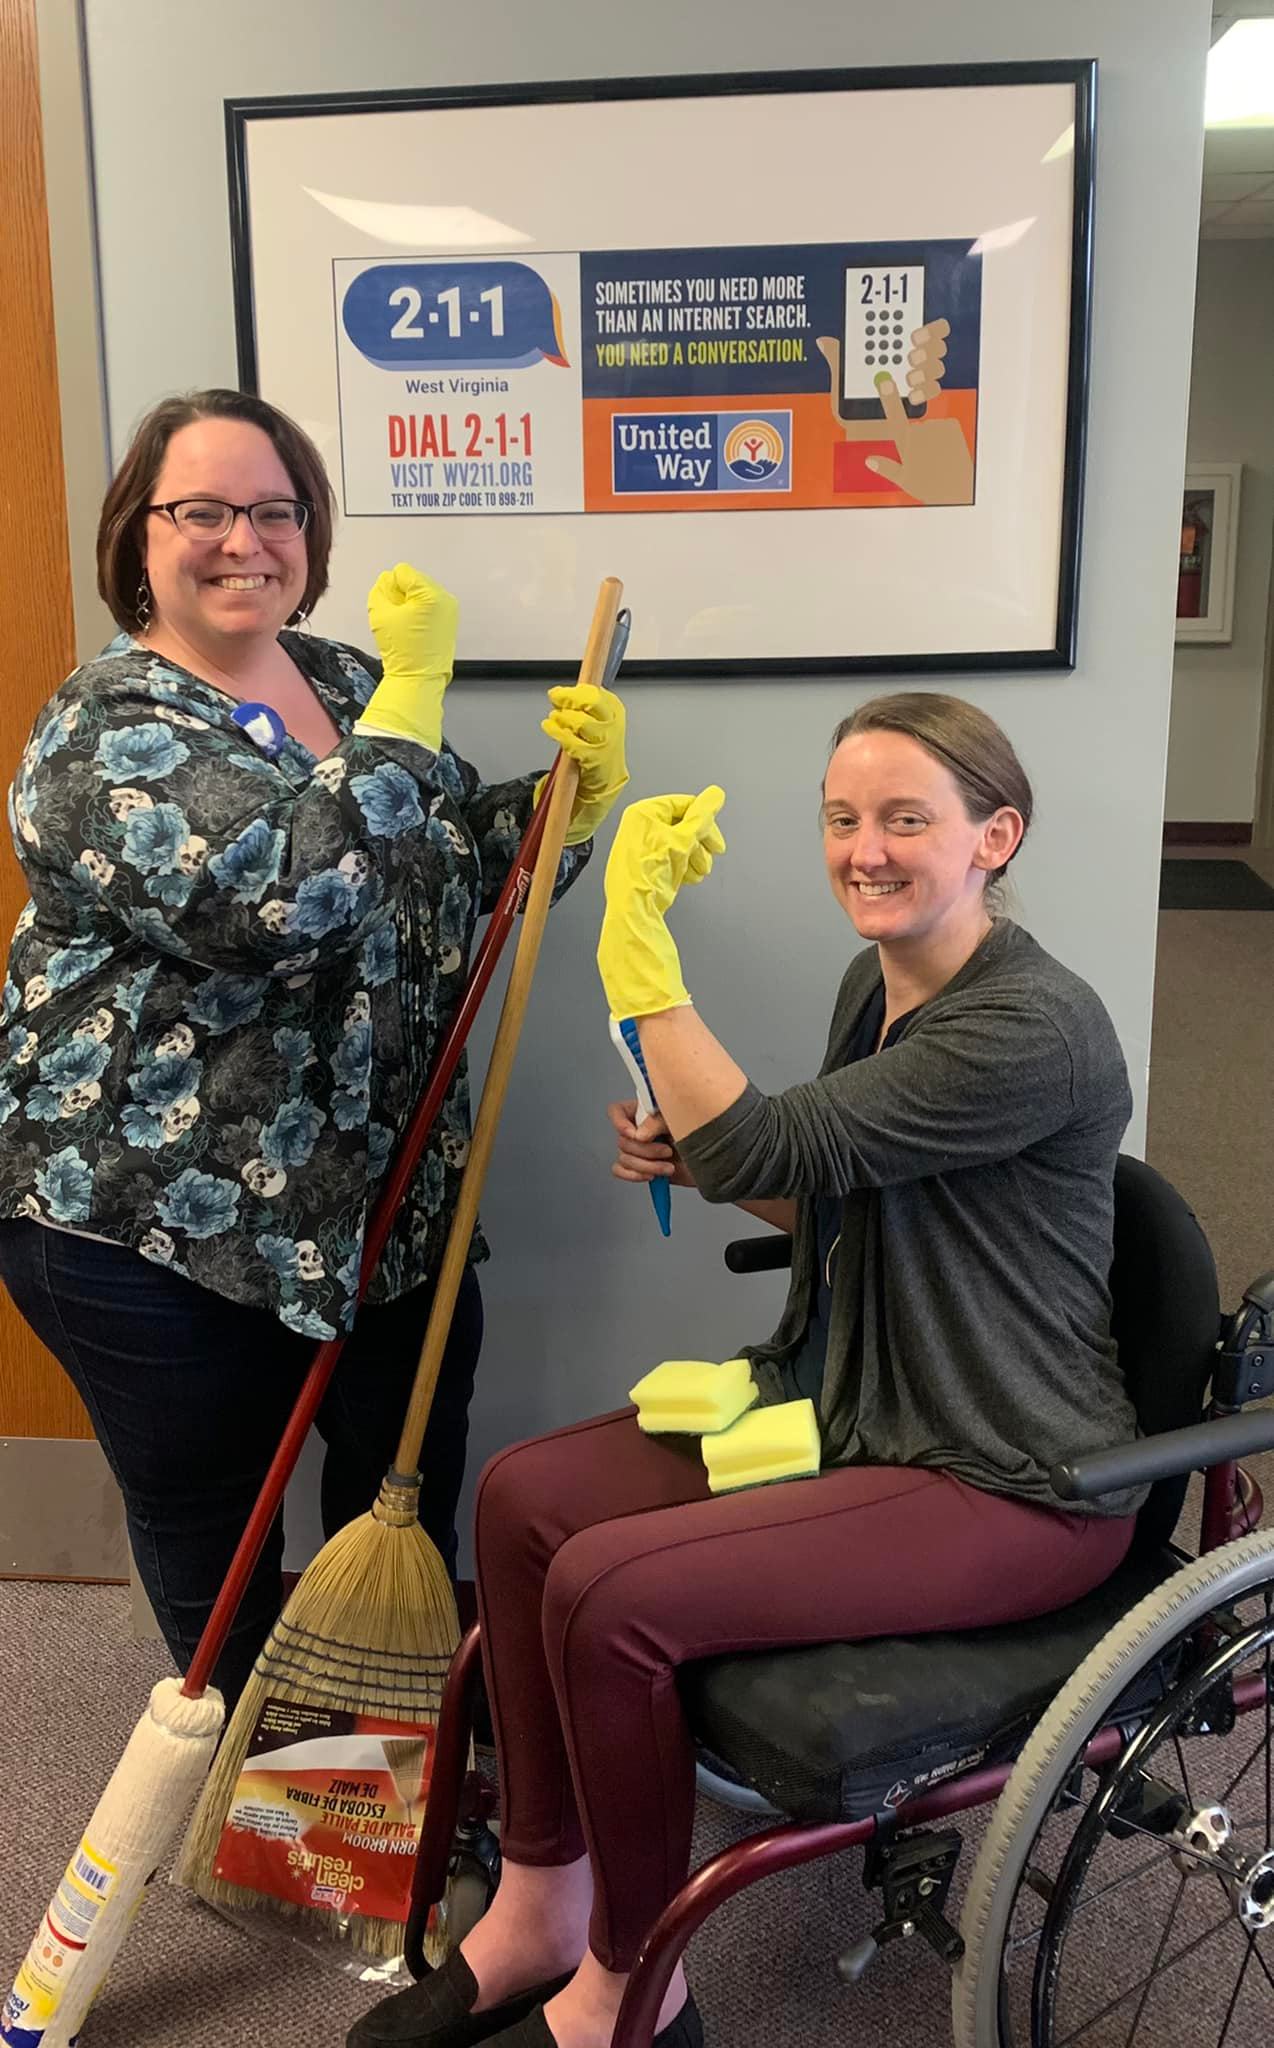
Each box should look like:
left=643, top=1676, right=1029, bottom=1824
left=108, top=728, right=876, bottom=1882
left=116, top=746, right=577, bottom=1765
left=176, top=578, right=625, bottom=1958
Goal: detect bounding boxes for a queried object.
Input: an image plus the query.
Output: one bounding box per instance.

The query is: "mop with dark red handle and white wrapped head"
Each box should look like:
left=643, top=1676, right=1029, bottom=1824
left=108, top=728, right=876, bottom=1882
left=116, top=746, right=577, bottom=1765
left=0, top=729, right=573, bottom=2048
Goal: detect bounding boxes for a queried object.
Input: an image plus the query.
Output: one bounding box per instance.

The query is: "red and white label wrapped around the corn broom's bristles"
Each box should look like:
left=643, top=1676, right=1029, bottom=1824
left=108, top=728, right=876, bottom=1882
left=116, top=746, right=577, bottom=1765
left=213, top=1698, right=436, bottom=1921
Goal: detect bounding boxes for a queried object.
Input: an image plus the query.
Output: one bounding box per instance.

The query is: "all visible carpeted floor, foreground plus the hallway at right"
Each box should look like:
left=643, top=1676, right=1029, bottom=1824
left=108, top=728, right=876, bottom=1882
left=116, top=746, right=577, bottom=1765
left=0, top=856, right=1274, bottom=2048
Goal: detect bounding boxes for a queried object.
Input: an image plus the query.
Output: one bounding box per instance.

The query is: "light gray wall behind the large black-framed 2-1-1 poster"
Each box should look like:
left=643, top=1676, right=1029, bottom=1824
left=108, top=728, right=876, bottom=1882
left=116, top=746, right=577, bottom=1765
left=86, top=0, right=1208, bottom=1564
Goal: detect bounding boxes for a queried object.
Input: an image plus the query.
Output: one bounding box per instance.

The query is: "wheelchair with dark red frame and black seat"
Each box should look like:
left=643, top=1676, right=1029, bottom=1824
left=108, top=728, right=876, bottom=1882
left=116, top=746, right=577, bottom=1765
left=406, top=1157, right=1274, bottom=2048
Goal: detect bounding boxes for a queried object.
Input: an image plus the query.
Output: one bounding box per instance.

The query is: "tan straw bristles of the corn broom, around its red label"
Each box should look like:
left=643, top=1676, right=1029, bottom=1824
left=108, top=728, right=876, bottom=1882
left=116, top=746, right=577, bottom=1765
left=176, top=1481, right=461, bottom=1958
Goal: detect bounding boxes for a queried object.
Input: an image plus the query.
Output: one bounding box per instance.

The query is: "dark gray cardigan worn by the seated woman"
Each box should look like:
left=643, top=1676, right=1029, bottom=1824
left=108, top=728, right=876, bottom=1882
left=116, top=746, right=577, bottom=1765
left=680, top=920, right=1143, bottom=1516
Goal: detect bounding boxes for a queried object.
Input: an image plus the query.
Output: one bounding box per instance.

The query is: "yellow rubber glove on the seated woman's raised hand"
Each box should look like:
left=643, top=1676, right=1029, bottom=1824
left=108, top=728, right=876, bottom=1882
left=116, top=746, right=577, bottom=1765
left=598, top=784, right=725, bottom=1018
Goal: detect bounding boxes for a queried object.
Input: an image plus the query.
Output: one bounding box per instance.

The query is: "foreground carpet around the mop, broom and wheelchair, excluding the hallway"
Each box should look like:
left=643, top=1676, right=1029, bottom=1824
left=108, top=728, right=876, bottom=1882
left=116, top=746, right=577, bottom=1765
left=0, top=1583, right=1003, bottom=2048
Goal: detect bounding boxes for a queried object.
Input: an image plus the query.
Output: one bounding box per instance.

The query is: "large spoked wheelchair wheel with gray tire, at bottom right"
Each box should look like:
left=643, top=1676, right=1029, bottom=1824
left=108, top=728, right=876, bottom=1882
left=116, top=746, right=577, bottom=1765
left=952, top=1530, right=1274, bottom=2048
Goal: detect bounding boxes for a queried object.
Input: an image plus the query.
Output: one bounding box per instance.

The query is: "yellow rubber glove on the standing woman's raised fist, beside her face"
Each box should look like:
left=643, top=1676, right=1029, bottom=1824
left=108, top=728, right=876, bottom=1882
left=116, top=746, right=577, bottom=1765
left=354, top=561, right=461, bottom=754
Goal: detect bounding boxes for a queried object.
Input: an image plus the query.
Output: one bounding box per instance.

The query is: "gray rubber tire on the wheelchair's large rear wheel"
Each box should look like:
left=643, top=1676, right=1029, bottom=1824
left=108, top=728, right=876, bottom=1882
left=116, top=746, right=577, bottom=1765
left=952, top=1530, right=1274, bottom=2048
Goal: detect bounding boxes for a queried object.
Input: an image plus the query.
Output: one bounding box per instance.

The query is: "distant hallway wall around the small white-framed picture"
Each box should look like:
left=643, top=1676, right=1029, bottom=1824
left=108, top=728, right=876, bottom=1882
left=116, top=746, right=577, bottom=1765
left=1165, top=242, right=1274, bottom=821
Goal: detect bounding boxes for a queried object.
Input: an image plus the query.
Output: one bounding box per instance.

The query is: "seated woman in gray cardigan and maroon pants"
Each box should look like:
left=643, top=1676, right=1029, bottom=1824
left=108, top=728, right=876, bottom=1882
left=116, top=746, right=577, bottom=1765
left=350, top=694, right=1145, bottom=2048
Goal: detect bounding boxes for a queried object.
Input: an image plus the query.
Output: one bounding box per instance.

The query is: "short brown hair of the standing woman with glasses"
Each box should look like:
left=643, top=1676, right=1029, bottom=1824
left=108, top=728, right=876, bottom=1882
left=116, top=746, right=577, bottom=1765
left=98, top=391, right=336, bottom=633
